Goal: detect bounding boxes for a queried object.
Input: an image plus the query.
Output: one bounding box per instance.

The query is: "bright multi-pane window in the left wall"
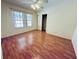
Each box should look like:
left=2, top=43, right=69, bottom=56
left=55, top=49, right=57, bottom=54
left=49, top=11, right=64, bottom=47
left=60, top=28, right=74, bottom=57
left=12, top=10, right=32, bottom=28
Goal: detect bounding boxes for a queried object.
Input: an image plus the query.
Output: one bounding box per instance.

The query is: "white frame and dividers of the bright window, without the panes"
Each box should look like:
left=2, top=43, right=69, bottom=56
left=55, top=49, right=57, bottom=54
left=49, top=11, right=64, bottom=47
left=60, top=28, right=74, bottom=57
left=11, top=9, right=33, bottom=28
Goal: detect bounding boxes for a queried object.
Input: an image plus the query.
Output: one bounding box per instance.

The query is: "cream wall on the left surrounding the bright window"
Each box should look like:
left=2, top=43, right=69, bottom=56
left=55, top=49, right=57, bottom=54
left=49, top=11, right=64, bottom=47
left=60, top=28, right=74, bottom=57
left=1, top=2, right=37, bottom=38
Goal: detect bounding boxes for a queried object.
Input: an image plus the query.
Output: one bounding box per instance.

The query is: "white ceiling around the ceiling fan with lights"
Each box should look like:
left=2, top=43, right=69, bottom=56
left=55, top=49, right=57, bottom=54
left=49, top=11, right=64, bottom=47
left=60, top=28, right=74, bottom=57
left=2, top=0, right=74, bottom=10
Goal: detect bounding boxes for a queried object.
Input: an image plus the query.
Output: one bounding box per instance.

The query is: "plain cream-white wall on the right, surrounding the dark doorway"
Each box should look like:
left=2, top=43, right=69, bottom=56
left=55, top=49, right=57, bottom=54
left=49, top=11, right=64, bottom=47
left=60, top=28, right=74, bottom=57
left=38, top=0, right=76, bottom=39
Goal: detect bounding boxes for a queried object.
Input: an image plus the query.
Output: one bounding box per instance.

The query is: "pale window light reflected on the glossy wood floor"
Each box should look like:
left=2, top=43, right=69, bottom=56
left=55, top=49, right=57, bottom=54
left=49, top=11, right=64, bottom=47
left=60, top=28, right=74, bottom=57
left=17, top=35, right=33, bottom=49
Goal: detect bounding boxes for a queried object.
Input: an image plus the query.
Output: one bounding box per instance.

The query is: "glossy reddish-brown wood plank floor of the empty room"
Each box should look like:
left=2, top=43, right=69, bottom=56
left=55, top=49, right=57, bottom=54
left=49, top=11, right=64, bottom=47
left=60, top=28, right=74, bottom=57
left=2, top=31, right=76, bottom=59
